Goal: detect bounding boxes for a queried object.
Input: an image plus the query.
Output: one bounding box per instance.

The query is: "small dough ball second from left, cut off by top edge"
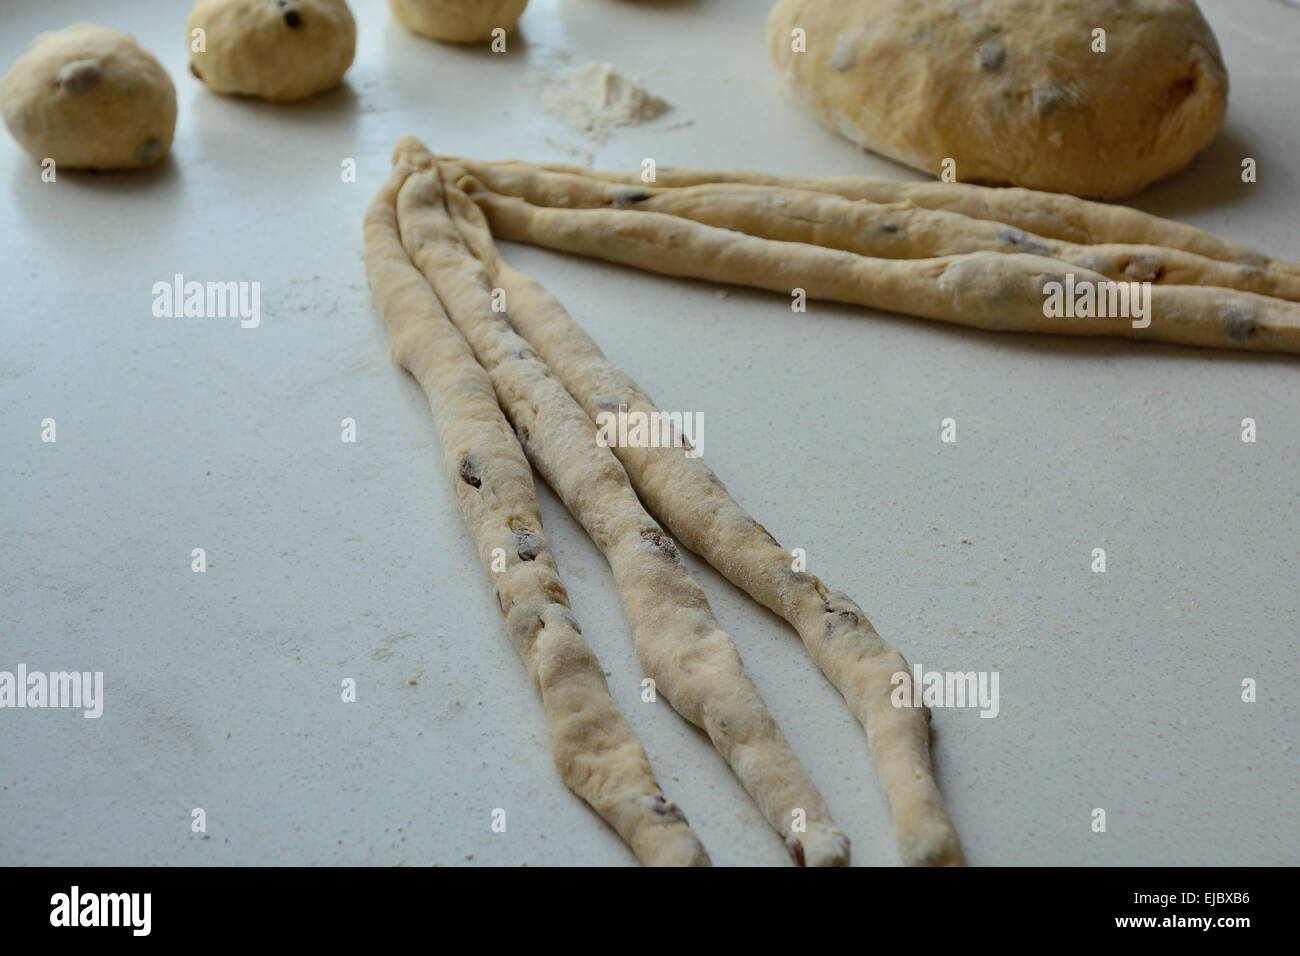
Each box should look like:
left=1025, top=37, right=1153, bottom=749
left=186, top=0, right=356, bottom=100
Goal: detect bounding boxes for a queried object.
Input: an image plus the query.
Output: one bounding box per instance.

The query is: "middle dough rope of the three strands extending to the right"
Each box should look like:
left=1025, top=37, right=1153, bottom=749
left=455, top=160, right=1300, bottom=302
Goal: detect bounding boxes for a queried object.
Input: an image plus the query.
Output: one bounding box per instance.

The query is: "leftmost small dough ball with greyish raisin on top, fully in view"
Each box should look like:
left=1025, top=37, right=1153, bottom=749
left=0, top=23, right=176, bottom=169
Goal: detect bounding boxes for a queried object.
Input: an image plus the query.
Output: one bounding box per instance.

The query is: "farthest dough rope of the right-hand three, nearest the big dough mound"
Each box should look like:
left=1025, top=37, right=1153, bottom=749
left=478, top=160, right=1300, bottom=274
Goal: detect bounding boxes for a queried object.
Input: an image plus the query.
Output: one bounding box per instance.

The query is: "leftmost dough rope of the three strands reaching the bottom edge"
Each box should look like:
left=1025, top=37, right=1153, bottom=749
left=365, top=155, right=709, bottom=866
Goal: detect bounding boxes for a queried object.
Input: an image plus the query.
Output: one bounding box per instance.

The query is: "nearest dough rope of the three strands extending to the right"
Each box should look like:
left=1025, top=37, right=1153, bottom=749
left=462, top=177, right=1300, bottom=352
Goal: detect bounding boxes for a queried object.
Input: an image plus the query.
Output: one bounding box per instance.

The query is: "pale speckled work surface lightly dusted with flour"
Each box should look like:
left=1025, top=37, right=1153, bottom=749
left=0, top=0, right=1300, bottom=865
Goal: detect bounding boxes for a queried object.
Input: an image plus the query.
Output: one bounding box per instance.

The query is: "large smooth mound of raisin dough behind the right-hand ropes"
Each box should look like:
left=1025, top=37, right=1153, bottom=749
left=767, top=0, right=1227, bottom=198
